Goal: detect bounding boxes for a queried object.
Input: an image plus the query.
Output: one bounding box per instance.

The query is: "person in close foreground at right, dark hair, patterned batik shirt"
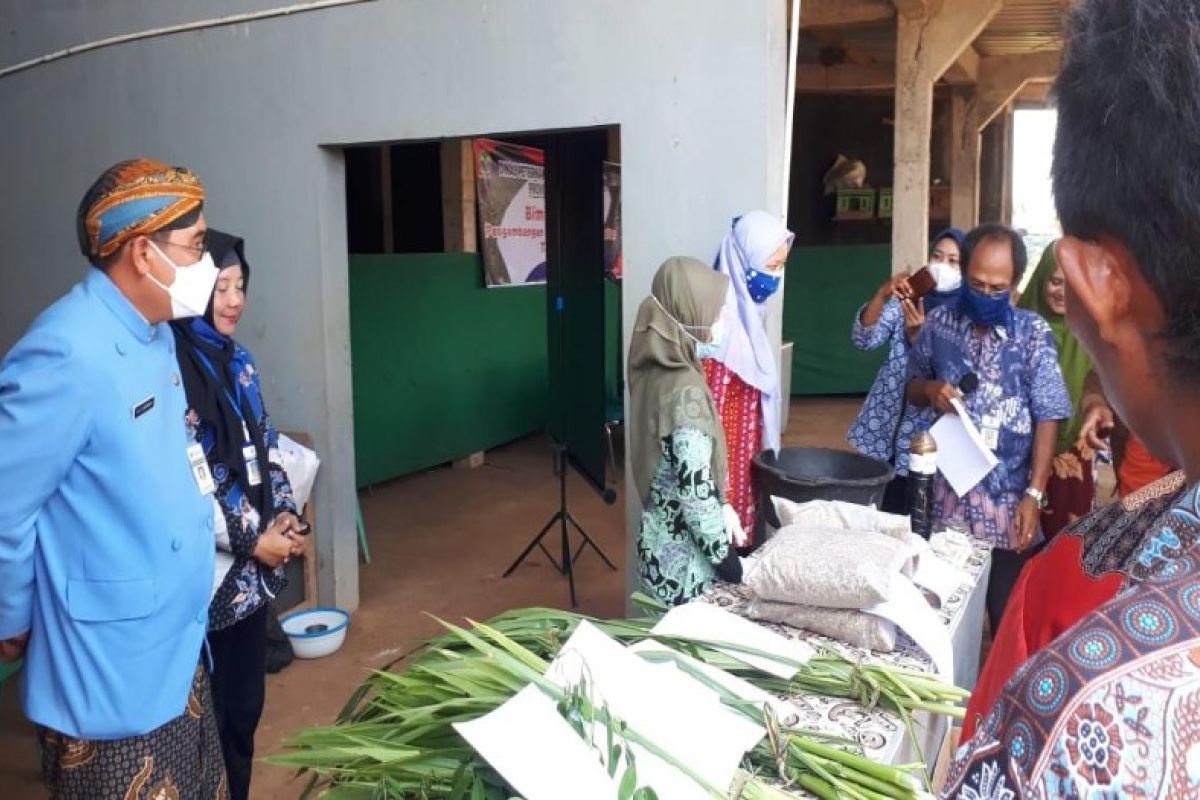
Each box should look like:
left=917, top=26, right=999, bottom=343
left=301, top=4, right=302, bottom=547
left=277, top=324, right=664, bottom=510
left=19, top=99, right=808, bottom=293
left=943, top=0, right=1200, bottom=799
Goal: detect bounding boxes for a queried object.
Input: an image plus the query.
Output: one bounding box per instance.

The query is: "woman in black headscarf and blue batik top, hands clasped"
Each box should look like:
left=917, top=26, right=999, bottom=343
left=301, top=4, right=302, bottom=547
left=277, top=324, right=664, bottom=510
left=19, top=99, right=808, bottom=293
left=172, top=228, right=304, bottom=800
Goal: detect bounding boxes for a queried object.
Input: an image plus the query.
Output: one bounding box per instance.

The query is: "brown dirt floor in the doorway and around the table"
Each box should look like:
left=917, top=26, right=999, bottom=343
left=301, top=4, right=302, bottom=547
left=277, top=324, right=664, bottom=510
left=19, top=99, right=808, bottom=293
left=0, top=398, right=1108, bottom=800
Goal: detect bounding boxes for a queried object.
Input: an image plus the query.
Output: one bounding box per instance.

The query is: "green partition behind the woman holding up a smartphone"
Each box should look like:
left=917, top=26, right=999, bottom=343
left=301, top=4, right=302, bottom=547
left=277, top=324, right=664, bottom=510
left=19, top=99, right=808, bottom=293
left=784, top=245, right=892, bottom=396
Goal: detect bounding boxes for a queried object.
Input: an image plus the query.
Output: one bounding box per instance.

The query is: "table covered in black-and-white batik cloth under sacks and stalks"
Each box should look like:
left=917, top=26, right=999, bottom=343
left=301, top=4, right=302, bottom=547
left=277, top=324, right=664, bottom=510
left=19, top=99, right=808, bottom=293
left=700, top=540, right=991, bottom=796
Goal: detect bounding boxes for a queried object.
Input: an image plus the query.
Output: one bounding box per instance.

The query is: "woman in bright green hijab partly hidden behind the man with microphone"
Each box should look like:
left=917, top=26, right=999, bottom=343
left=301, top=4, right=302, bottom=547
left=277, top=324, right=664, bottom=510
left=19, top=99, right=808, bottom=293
left=1018, top=242, right=1096, bottom=539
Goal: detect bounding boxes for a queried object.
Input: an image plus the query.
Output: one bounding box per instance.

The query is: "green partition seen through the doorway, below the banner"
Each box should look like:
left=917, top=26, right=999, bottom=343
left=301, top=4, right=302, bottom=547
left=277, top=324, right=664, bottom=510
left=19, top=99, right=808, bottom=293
left=350, top=253, right=548, bottom=486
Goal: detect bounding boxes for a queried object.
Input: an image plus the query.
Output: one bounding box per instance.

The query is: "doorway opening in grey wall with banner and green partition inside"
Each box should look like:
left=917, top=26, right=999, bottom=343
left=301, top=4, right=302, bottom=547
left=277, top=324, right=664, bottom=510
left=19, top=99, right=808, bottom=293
left=343, top=128, right=624, bottom=615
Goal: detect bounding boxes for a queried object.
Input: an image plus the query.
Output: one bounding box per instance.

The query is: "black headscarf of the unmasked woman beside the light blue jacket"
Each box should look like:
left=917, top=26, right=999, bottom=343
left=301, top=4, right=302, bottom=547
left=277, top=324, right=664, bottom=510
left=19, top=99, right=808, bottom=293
left=170, top=228, right=274, bottom=522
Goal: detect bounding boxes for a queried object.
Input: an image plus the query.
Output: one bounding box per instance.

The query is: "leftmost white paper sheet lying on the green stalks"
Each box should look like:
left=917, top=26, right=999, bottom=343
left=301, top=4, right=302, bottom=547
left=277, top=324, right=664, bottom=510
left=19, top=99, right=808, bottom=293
left=455, top=685, right=618, bottom=800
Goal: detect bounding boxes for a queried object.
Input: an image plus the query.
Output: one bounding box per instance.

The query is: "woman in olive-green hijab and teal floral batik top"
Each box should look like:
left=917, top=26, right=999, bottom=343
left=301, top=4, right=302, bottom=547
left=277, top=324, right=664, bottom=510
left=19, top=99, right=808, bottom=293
left=629, top=258, right=742, bottom=606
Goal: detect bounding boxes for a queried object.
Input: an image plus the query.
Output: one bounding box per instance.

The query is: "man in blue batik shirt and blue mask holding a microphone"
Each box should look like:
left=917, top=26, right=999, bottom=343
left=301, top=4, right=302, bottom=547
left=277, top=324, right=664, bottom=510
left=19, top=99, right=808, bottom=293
left=908, top=225, right=1072, bottom=631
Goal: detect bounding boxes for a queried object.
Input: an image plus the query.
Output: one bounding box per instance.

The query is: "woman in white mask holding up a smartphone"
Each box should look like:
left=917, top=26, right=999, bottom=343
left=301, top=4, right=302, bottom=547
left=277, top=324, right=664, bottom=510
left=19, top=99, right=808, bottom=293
left=846, top=228, right=966, bottom=513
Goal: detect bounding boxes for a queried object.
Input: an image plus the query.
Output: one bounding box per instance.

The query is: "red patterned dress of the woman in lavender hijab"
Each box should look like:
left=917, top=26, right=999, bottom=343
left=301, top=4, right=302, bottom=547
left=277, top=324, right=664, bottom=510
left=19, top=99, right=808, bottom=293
left=703, top=359, right=762, bottom=546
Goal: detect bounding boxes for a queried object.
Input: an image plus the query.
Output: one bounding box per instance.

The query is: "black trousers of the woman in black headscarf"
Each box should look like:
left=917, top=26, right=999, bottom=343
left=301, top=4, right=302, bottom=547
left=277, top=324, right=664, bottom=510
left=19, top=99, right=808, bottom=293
left=209, top=606, right=268, bottom=800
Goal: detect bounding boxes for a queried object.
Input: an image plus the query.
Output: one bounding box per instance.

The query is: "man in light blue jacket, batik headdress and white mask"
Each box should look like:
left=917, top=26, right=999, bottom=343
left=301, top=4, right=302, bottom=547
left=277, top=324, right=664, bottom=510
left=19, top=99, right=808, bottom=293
left=0, top=160, right=226, bottom=800
